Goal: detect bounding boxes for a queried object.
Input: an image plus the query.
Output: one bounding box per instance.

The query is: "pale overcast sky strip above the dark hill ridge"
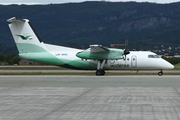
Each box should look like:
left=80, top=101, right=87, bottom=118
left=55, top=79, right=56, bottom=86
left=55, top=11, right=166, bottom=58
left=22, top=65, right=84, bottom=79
left=0, top=0, right=180, bottom=5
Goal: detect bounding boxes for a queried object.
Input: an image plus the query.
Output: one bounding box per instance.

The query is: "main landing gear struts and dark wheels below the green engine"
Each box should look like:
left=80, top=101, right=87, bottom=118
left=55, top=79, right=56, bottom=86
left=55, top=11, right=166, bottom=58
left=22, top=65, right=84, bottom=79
left=96, top=60, right=106, bottom=76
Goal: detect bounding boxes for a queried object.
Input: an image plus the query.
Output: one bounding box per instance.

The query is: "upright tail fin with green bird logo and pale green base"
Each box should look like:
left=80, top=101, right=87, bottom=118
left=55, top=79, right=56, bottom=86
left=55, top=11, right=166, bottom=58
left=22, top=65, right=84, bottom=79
left=7, top=17, right=46, bottom=53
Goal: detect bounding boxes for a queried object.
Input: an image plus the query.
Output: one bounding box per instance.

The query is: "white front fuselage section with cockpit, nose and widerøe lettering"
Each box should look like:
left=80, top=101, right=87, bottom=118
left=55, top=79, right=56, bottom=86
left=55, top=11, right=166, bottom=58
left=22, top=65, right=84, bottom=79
left=104, top=51, right=174, bottom=70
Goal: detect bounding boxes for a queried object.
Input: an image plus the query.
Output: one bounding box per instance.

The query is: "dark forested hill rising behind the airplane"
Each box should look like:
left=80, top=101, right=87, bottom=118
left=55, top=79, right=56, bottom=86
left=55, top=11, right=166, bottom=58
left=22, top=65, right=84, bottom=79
left=0, top=2, right=180, bottom=53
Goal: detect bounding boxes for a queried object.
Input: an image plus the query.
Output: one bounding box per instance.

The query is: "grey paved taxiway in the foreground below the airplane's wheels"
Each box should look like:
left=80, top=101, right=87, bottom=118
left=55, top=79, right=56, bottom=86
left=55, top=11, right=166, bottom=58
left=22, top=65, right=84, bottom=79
left=0, top=75, right=180, bottom=120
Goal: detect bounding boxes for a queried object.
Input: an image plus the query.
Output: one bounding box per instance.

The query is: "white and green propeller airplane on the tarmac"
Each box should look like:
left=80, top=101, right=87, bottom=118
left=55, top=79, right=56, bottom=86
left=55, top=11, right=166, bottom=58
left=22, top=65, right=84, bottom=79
left=7, top=17, right=174, bottom=76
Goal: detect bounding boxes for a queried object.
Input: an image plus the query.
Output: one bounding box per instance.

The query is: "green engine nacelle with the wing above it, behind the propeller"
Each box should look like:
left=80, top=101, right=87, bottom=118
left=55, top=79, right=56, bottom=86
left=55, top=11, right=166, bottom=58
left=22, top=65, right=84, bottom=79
left=76, top=45, right=124, bottom=60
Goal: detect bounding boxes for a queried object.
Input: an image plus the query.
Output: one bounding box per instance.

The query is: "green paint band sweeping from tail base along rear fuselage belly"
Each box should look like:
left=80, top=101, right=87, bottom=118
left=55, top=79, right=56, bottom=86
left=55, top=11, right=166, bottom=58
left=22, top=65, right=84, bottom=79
left=17, top=43, right=97, bottom=70
